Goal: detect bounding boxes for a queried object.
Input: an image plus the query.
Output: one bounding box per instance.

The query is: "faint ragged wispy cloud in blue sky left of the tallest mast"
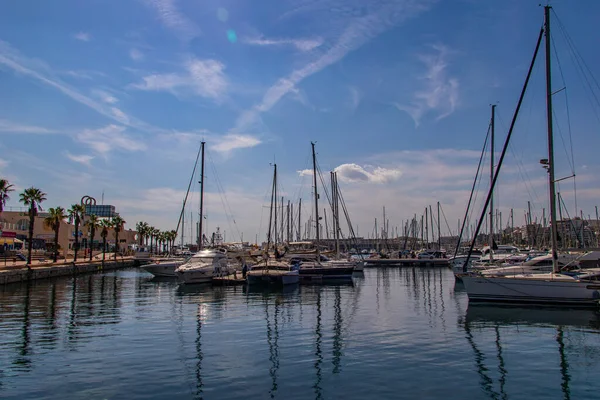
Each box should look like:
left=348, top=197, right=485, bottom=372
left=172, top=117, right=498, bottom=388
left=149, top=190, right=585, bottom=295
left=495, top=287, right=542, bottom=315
left=395, top=45, right=459, bottom=126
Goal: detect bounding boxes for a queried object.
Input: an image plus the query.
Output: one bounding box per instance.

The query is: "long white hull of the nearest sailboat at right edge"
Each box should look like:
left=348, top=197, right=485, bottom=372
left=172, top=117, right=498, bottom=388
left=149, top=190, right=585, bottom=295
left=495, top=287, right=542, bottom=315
left=462, top=276, right=600, bottom=306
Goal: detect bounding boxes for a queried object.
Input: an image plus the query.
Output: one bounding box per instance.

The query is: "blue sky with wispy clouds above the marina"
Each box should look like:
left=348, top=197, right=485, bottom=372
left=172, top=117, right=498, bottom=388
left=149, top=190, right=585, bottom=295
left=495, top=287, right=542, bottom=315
left=0, top=0, right=600, bottom=241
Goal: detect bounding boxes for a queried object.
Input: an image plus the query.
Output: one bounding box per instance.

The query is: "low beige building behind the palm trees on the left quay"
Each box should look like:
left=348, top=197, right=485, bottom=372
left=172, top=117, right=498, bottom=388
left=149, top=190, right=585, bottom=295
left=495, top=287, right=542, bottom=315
left=0, top=209, right=137, bottom=256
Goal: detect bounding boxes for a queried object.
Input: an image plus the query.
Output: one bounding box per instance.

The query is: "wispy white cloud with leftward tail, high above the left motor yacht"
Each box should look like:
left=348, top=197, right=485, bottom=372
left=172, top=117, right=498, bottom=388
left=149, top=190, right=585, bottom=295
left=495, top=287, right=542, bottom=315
left=130, top=58, right=228, bottom=100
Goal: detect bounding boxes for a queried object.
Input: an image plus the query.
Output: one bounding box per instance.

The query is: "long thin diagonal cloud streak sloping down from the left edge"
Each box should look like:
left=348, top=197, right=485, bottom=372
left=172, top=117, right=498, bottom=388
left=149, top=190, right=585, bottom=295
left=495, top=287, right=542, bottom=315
left=0, top=40, right=162, bottom=132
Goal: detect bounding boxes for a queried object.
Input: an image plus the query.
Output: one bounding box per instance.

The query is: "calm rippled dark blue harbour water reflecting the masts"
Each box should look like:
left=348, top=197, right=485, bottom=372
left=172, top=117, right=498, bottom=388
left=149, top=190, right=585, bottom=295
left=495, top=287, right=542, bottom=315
left=0, top=268, right=600, bottom=399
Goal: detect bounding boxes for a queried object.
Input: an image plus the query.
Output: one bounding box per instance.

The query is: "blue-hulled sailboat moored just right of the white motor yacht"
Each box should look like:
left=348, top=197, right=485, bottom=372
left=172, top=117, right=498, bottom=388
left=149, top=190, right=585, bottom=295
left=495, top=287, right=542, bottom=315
left=246, top=164, right=300, bottom=285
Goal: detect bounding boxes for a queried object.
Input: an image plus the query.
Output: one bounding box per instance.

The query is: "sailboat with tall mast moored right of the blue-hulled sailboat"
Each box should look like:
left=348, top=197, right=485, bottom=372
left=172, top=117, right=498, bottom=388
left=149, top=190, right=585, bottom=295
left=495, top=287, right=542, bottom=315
left=300, top=142, right=354, bottom=282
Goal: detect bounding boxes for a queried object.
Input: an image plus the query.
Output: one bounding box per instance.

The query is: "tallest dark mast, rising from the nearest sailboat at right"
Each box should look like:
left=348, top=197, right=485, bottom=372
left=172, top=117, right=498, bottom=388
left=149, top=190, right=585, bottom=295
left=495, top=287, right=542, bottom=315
left=544, top=6, right=558, bottom=272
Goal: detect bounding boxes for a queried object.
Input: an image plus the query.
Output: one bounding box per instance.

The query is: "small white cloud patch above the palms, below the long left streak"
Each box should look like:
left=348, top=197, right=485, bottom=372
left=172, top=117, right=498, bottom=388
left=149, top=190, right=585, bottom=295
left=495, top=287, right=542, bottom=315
left=76, top=124, right=146, bottom=158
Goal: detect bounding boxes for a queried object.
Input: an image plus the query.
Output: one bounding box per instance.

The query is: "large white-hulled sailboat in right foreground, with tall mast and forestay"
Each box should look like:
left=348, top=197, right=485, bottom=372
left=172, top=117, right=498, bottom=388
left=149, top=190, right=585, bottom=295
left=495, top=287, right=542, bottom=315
left=462, top=6, right=600, bottom=306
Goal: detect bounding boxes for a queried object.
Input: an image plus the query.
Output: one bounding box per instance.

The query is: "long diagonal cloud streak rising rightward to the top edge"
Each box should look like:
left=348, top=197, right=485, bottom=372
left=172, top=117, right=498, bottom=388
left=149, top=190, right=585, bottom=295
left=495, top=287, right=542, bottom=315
left=232, top=0, right=434, bottom=132
